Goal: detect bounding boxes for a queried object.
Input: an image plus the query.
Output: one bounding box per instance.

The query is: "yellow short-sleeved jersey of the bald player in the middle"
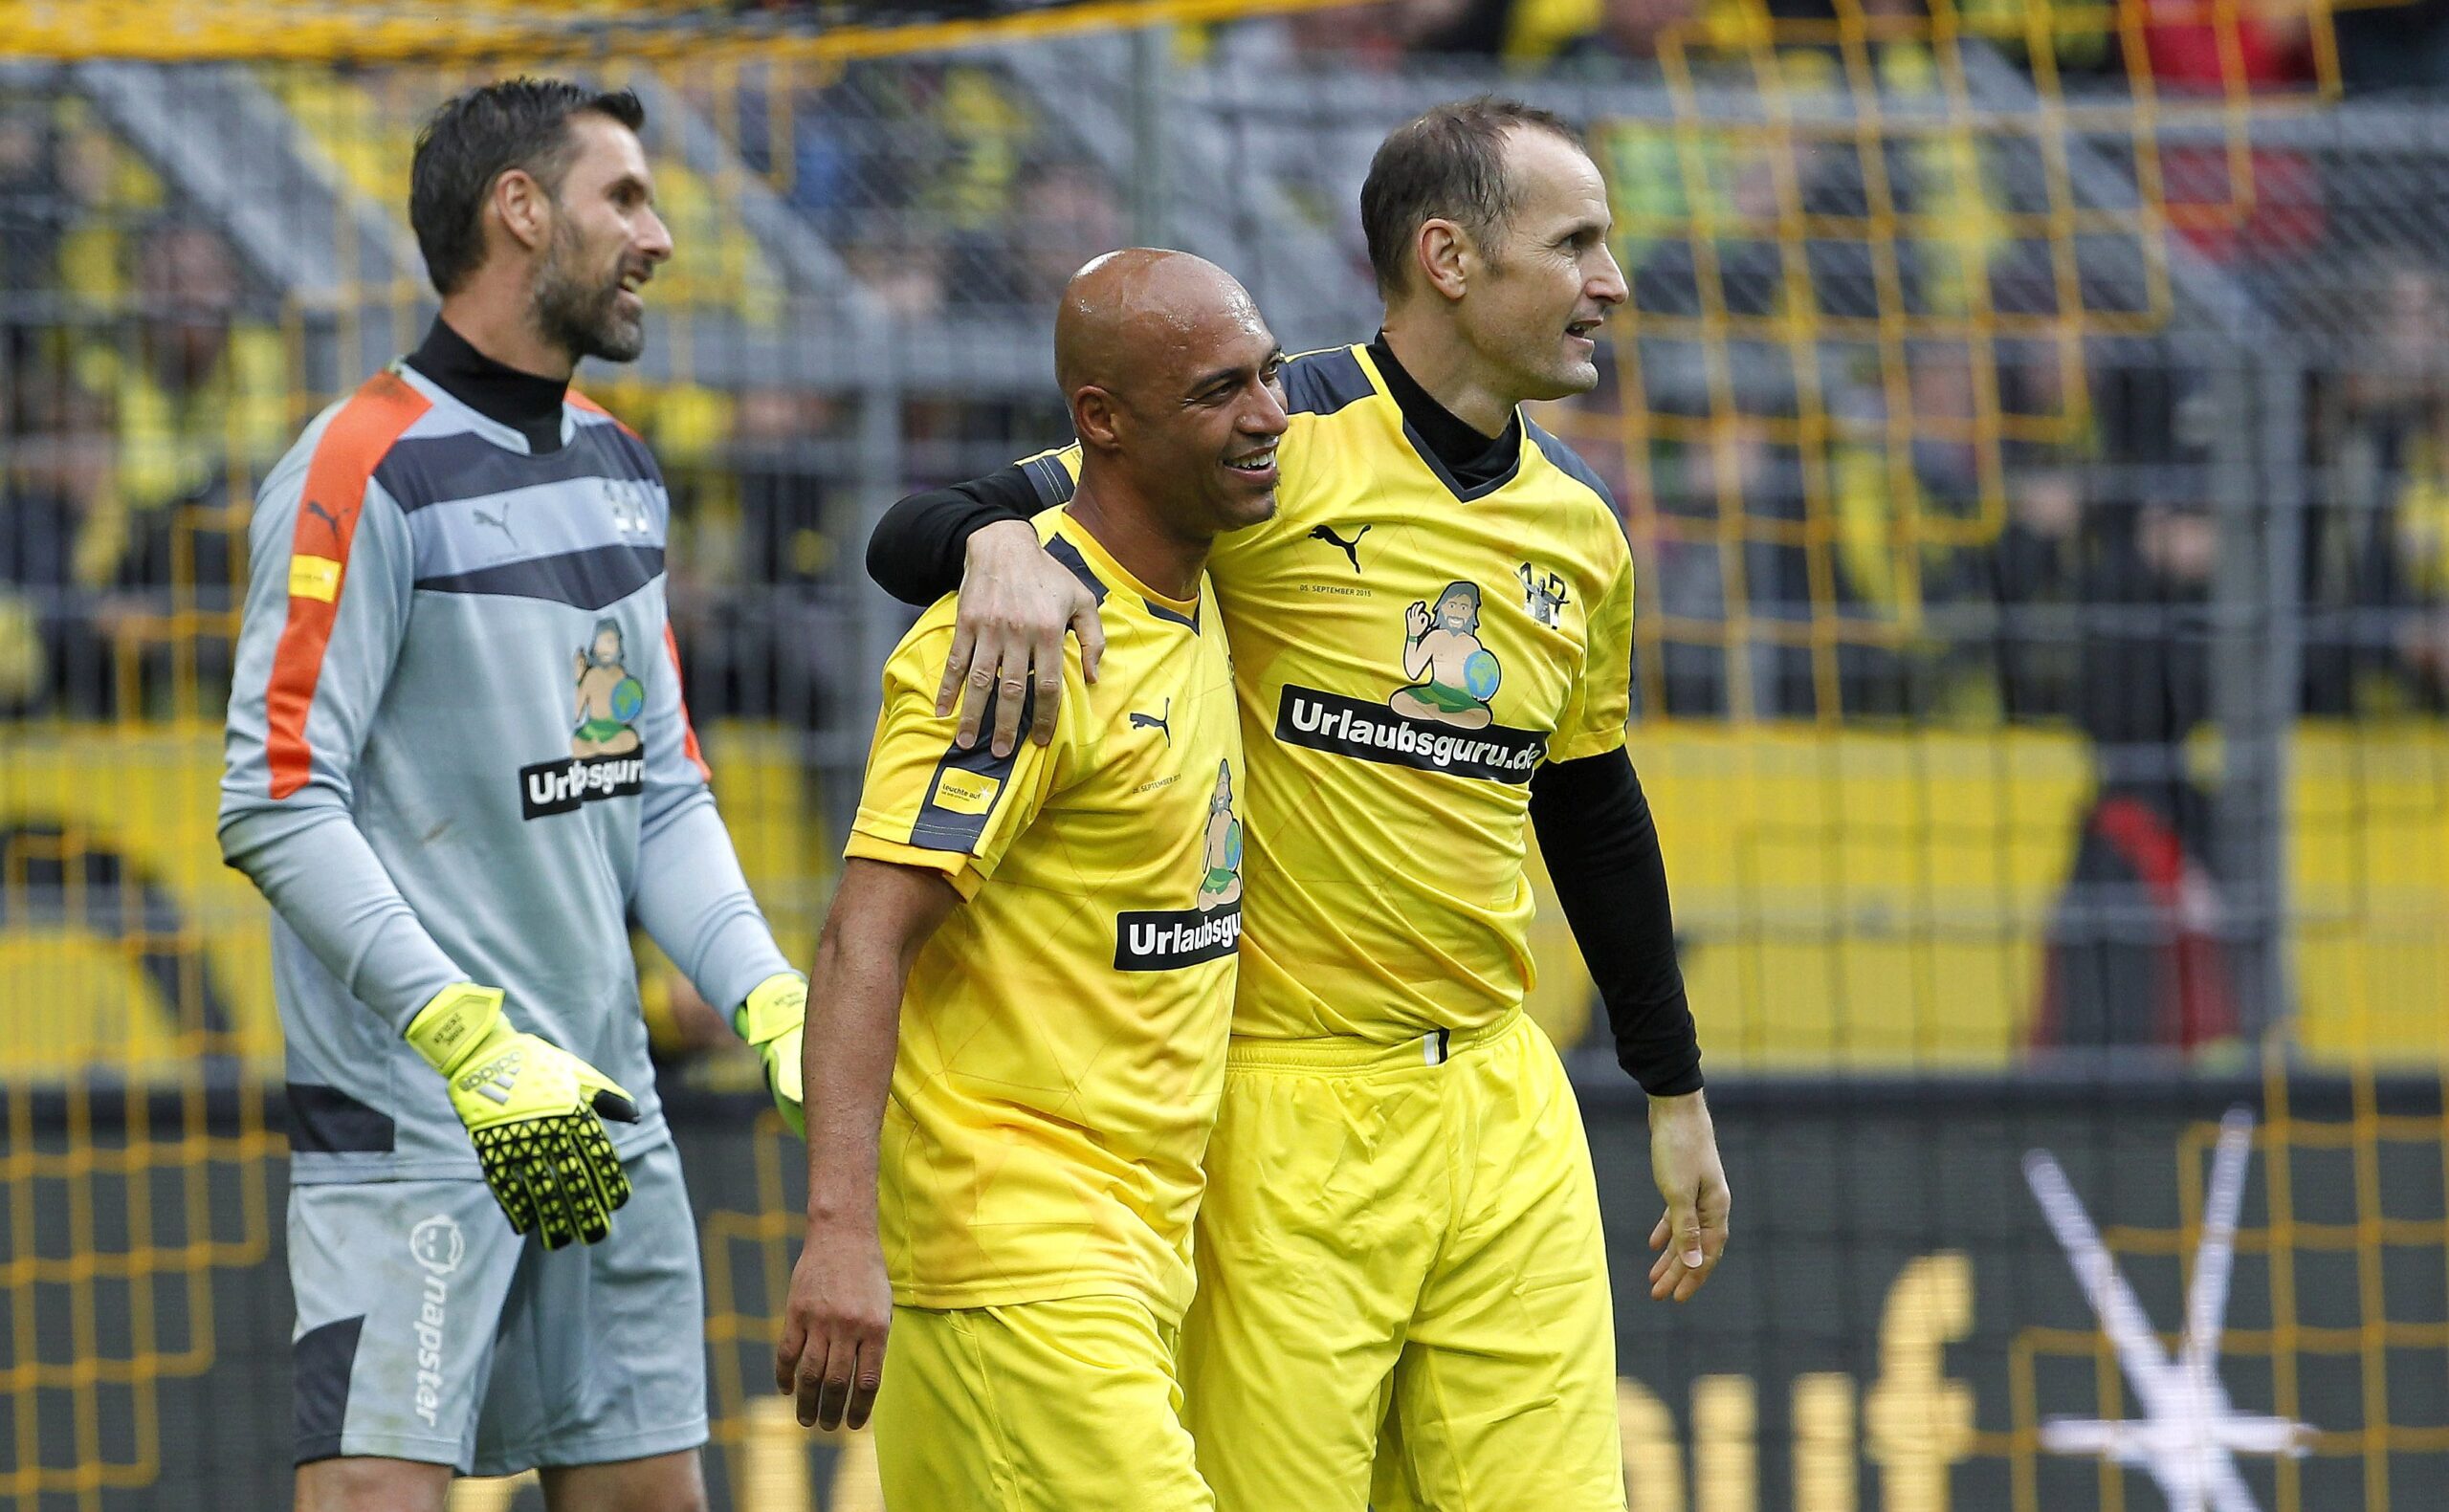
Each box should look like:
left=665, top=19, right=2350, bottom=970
left=848, top=509, right=1244, bottom=1321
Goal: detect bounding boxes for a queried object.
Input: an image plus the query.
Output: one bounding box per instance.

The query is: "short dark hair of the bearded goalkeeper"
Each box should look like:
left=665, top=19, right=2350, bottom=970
left=409, top=78, right=647, bottom=294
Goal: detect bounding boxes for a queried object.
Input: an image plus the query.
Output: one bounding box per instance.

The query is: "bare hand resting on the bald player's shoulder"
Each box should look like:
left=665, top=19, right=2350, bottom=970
left=936, top=521, right=1105, bottom=756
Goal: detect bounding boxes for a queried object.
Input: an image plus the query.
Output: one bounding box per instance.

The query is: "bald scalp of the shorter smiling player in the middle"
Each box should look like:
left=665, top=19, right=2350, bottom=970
left=1055, top=247, right=1267, bottom=402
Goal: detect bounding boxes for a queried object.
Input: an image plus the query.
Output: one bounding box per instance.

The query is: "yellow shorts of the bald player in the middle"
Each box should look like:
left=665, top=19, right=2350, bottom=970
left=874, top=1297, right=1215, bottom=1512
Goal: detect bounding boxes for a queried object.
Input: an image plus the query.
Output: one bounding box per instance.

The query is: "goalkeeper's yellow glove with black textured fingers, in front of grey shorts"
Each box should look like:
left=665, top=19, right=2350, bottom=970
left=407, top=981, right=637, bottom=1250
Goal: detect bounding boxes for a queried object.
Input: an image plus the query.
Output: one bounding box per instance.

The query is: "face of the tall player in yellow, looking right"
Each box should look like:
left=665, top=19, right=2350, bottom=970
left=1455, top=127, right=1626, bottom=399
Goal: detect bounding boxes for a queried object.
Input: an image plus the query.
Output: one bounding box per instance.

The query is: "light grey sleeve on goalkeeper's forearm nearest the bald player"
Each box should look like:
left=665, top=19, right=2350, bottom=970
left=629, top=788, right=791, bottom=1011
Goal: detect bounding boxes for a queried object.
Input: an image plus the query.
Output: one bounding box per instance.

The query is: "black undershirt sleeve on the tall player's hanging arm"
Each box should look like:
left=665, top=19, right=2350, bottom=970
left=1531, top=749, right=1702, bottom=1096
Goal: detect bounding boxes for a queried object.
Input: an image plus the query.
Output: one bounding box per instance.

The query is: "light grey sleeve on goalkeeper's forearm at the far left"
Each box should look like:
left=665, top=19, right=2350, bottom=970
left=220, top=805, right=468, bottom=1033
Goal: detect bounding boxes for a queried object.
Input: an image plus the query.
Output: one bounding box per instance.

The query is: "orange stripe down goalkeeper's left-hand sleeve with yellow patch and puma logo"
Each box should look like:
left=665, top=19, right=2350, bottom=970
left=264, top=372, right=431, bottom=798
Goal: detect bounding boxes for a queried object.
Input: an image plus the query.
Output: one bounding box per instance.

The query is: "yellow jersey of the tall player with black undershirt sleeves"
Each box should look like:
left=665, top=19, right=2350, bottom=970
left=1004, top=347, right=1634, bottom=1042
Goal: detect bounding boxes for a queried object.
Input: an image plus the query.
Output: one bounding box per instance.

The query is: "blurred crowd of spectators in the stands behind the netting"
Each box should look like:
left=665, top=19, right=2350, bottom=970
left=0, top=15, right=2449, bottom=734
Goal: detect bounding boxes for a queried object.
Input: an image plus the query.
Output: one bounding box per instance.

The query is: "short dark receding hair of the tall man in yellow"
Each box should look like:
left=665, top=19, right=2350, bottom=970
left=1361, top=96, right=1582, bottom=298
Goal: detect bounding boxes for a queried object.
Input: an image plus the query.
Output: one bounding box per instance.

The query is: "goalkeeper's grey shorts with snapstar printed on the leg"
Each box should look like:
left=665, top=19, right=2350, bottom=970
left=289, top=1143, right=705, bottom=1476
